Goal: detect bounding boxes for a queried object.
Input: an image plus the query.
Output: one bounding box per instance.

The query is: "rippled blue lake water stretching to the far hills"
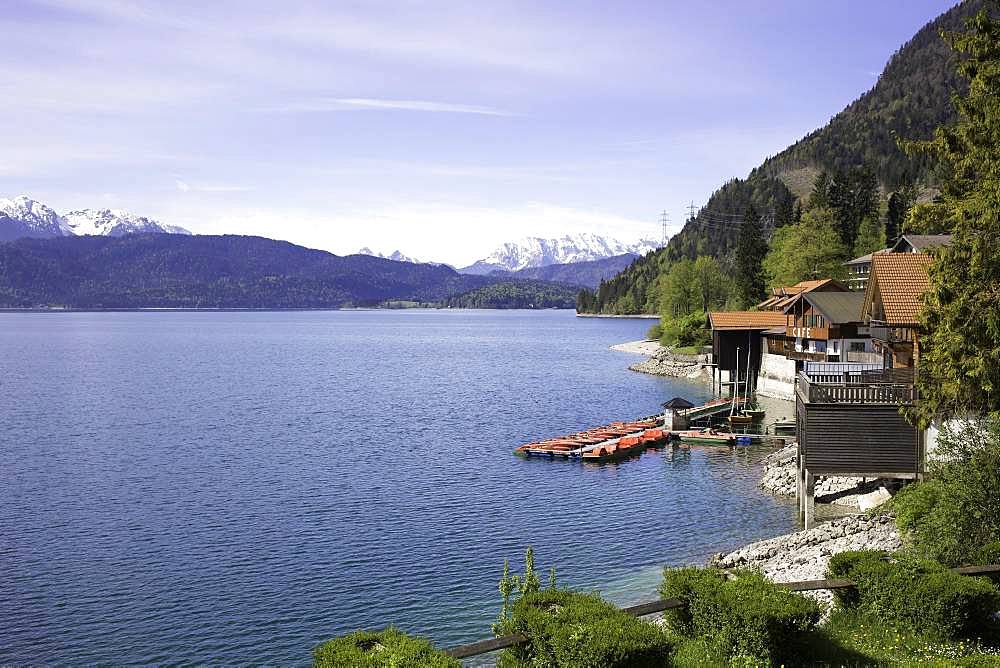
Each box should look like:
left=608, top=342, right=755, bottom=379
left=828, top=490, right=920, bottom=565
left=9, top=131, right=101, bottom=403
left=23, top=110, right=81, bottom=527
left=0, top=311, right=795, bottom=664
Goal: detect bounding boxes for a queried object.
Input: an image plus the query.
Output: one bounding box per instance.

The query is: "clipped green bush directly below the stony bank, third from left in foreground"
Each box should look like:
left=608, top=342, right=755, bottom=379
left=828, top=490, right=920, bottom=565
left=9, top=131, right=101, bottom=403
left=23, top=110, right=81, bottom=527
left=660, top=568, right=820, bottom=665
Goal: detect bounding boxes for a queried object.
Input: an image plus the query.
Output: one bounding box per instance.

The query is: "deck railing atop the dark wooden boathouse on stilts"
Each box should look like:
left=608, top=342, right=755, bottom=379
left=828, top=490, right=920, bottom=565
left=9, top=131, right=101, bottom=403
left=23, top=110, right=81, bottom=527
left=796, top=370, right=917, bottom=404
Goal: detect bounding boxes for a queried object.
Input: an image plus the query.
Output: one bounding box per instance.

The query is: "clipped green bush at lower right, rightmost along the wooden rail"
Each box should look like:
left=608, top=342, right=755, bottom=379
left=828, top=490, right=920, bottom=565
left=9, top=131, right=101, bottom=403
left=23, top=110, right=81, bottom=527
left=831, top=553, right=1000, bottom=638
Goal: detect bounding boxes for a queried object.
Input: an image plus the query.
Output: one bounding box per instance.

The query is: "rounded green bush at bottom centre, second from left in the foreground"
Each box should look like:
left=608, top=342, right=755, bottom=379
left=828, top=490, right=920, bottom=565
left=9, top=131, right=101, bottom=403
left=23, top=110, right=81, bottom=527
left=498, top=589, right=671, bottom=668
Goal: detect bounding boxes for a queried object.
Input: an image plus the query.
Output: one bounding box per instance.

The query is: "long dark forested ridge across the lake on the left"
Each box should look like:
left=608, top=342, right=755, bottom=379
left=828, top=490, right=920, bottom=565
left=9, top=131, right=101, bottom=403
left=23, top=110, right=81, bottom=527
left=0, top=234, right=508, bottom=308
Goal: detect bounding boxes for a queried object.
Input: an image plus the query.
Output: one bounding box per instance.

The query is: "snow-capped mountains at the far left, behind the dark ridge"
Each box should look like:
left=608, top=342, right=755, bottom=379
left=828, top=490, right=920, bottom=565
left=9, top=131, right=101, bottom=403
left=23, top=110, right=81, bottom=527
left=0, top=195, right=191, bottom=241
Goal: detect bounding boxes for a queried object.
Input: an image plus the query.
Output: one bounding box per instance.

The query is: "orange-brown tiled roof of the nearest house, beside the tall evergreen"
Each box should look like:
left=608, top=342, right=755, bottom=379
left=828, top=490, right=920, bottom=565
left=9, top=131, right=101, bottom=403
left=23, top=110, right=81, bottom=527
left=864, top=253, right=934, bottom=325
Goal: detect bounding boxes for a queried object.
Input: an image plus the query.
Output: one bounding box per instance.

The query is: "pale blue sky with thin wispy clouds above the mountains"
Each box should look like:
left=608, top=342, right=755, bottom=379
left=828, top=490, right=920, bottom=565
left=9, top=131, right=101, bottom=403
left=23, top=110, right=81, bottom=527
left=0, top=0, right=951, bottom=265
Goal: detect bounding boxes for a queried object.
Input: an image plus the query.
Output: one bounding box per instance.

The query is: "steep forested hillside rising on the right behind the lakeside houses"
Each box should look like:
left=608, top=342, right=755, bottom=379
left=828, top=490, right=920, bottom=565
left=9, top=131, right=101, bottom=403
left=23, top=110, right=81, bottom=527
left=578, top=0, right=983, bottom=313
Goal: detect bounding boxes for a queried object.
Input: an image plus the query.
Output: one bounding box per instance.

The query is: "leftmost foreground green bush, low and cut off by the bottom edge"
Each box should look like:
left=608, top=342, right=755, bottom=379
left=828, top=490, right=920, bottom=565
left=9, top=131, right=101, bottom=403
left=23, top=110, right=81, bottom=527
left=313, top=628, right=461, bottom=668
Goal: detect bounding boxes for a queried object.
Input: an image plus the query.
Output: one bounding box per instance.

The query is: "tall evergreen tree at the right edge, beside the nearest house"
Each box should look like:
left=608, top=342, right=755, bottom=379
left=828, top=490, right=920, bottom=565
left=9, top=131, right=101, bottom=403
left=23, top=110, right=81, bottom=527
left=913, top=3, right=1000, bottom=425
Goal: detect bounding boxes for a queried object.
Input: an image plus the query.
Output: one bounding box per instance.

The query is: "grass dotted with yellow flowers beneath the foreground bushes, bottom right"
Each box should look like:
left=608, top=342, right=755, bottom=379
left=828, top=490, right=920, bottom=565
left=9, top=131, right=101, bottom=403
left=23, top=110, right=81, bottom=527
left=673, top=611, right=1000, bottom=668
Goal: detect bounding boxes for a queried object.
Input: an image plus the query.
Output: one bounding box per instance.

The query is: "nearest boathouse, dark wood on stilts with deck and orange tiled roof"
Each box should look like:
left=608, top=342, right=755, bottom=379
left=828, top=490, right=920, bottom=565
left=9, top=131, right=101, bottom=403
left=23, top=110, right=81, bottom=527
left=795, top=253, right=932, bottom=527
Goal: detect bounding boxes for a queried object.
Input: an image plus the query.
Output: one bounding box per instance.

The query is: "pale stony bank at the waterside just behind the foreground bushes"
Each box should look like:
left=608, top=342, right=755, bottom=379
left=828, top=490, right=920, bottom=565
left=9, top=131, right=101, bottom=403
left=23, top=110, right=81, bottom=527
left=710, top=513, right=903, bottom=603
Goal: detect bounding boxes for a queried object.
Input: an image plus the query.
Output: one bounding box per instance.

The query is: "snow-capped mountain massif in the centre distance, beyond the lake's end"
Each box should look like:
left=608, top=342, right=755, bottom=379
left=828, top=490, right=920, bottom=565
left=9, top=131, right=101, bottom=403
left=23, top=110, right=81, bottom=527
left=461, top=232, right=658, bottom=273
